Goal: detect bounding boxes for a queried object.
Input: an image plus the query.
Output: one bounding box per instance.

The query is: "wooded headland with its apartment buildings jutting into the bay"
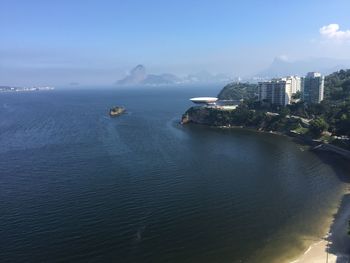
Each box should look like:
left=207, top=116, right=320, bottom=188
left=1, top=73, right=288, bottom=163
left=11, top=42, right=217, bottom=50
left=181, top=70, right=350, bottom=154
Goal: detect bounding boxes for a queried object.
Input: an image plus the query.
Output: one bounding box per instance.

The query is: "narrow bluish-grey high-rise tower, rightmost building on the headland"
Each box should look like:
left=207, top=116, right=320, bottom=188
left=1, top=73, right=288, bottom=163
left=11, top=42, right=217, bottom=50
left=302, top=72, right=324, bottom=103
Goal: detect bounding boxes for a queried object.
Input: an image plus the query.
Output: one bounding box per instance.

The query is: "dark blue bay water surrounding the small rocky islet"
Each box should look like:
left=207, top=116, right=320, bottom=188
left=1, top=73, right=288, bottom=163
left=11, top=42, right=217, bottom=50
left=0, top=86, right=344, bottom=263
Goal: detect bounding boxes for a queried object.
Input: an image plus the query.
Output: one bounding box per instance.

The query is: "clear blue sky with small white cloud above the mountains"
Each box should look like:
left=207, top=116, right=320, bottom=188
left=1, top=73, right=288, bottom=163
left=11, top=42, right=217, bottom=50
left=0, top=0, right=350, bottom=85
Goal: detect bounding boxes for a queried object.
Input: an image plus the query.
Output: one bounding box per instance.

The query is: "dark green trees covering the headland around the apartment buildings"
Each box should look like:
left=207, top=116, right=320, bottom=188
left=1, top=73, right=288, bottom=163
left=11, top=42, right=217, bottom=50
left=184, top=70, right=350, bottom=150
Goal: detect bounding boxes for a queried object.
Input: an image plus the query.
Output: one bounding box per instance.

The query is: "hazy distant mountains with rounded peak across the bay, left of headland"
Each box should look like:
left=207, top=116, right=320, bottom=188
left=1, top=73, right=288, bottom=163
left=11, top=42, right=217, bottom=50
left=116, top=65, right=232, bottom=86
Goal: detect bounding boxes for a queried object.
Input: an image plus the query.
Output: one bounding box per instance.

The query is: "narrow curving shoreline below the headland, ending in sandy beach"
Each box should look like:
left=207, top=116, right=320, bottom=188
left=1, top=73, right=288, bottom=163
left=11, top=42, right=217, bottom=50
left=183, top=123, right=350, bottom=263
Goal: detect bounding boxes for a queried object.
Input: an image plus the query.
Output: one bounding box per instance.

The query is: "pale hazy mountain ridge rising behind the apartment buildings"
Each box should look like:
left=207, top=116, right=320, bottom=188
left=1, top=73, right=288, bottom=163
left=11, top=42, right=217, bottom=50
left=254, top=58, right=350, bottom=78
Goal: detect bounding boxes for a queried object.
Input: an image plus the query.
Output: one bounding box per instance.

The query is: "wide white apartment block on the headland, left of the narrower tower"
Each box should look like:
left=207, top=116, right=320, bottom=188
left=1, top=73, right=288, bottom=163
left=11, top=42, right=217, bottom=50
left=259, top=78, right=293, bottom=106
